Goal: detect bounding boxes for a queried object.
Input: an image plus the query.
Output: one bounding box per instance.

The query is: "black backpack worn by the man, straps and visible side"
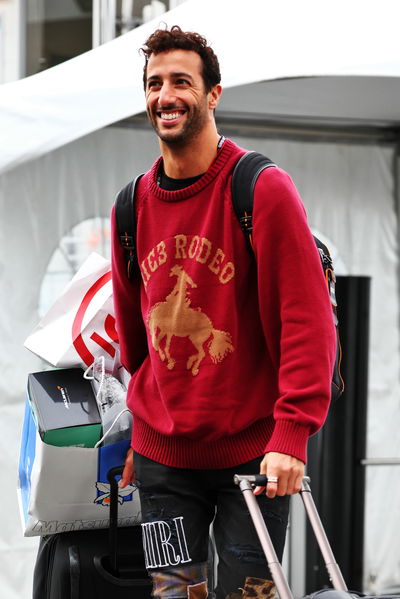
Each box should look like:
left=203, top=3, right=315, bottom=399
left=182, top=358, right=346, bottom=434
left=115, top=152, right=344, bottom=400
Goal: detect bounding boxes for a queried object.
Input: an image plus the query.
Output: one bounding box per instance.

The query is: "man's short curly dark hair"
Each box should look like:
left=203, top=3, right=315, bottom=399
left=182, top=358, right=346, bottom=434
left=141, top=25, right=221, bottom=92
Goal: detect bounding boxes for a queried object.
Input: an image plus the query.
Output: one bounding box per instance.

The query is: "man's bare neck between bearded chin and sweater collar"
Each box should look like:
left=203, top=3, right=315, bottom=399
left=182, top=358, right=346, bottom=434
left=160, top=129, right=220, bottom=179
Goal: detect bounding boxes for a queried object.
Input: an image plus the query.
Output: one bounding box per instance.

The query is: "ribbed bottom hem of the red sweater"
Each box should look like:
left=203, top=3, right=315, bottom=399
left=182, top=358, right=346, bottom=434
left=132, top=416, right=274, bottom=470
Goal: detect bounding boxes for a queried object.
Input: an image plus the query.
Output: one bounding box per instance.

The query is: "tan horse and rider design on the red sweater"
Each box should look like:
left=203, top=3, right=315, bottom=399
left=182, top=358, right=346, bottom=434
left=147, top=264, right=235, bottom=375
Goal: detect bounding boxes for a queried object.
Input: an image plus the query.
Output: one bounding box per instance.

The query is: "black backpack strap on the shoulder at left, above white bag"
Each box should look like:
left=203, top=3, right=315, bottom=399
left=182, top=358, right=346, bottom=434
left=115, top=174, right=143, bottom=279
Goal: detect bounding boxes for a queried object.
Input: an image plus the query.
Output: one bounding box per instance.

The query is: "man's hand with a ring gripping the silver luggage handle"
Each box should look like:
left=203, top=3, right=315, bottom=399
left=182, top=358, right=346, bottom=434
left=254, top=451, right=304, bottom=499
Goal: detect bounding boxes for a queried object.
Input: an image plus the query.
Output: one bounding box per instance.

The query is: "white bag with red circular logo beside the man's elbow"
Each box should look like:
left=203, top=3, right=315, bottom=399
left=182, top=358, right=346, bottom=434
left=24, top=252, right=129, bottom=383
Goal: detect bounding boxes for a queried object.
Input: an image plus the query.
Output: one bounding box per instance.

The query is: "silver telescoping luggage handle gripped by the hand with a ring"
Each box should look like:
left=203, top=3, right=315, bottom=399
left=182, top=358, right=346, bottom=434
left=234, top=474, right=347, bottom=599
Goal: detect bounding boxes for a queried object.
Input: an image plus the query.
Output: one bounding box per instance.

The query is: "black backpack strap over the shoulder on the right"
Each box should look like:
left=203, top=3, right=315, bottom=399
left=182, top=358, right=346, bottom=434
left=232, top=152, right=276, bottom=251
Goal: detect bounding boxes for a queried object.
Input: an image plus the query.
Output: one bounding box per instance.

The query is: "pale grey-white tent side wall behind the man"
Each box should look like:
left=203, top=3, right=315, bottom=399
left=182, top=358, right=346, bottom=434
left=0, top=127, right=400, bottom=599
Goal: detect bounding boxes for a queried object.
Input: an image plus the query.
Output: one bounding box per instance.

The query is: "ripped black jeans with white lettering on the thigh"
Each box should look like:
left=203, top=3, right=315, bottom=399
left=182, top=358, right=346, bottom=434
left=134, top=453, right=289, bottom=599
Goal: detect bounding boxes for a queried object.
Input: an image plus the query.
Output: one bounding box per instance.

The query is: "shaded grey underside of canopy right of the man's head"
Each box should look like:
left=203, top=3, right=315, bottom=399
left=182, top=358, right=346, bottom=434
left=218, top=75, right=400, bottom=128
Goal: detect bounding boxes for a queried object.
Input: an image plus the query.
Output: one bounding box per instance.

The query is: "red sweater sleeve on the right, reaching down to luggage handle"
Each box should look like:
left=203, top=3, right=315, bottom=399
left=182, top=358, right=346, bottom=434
left=253, top=168, right=336, bottom=462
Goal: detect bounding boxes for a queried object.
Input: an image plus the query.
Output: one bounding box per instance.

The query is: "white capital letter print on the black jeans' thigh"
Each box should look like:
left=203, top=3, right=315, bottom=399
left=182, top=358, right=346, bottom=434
left=142, top=516, right=192, bottom=568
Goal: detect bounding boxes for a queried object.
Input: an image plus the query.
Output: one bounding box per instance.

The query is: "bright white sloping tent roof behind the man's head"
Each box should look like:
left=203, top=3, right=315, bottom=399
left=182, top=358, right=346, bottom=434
left=0, top=0, right=400, bottom=173
